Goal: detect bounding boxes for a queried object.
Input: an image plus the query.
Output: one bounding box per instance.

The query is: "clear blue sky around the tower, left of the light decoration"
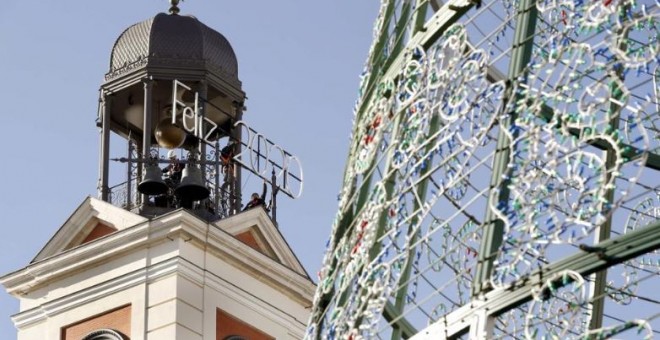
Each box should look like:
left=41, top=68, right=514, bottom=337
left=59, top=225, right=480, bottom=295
left=0, top=0, right=379, bottom=339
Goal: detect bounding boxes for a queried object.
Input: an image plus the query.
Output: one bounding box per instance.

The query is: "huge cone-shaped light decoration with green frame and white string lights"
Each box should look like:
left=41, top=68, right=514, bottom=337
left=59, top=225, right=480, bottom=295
left=306, top=0, right=660, bottom=340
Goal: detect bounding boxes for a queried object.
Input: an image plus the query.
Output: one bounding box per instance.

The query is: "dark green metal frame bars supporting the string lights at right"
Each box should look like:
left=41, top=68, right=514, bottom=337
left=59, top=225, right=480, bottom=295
left=308, top=0, right=660, bottom=339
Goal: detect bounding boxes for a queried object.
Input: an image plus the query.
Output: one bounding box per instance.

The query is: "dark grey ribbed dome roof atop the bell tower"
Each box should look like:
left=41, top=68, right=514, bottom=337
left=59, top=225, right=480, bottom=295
left=108, top=13, right=238, bottom=79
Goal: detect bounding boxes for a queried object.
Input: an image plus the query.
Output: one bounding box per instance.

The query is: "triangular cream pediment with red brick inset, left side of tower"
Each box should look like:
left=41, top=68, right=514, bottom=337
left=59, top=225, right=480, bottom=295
left=32, top=197, right=147, bottom=262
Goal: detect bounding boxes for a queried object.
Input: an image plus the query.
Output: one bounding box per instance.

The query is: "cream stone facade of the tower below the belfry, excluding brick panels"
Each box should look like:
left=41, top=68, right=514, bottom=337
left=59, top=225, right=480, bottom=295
left=0, top=198, right=315, bottom=340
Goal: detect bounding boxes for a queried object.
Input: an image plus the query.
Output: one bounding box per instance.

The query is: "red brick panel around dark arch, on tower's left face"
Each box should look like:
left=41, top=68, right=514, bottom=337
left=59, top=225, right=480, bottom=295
left=61, top=305, right=131, bottom=340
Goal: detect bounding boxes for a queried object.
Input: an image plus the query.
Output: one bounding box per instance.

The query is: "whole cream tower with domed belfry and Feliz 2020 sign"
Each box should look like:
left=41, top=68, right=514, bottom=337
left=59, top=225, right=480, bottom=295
left=0, top=1, right=315, bottom=340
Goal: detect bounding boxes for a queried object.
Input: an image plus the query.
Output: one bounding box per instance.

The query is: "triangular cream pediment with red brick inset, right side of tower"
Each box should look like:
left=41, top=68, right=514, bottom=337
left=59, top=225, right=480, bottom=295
left=215, top=208, right=309, bottom=277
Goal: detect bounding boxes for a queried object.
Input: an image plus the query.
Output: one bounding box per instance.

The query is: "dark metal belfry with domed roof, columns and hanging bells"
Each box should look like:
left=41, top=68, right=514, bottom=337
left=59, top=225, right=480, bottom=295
left=97, top=5, right=246, bottom=219
